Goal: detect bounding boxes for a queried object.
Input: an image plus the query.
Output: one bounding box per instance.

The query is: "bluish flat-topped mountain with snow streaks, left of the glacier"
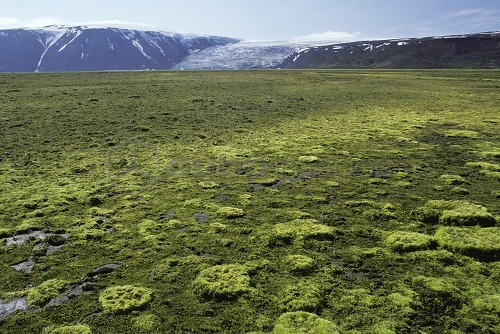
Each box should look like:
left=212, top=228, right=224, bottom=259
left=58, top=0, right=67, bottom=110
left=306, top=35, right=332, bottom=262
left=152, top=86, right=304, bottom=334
left=0, top=26, right=239, bottom=72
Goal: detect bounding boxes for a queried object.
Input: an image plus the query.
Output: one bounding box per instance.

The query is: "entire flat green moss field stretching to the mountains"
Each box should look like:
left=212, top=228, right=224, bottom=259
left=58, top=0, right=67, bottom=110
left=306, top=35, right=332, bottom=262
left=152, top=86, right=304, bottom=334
left=0, top=70, right=500, bottom=334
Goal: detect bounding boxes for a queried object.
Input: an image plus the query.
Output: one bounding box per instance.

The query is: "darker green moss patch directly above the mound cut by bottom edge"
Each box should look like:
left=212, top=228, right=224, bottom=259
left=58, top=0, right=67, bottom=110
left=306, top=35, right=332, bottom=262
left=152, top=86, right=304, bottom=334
left=279, top=281, right=323, bottom=312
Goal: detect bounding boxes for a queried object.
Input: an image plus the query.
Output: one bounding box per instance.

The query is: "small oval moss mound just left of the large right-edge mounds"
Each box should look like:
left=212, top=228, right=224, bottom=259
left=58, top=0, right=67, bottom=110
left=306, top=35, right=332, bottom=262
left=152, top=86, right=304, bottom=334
left=384, top=231, right=437, bottom=253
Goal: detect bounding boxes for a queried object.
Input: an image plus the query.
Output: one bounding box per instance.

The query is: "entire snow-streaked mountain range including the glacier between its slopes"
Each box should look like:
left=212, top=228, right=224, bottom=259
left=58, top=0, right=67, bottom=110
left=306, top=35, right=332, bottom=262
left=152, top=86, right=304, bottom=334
left=0, top=26, right=500, bottom=72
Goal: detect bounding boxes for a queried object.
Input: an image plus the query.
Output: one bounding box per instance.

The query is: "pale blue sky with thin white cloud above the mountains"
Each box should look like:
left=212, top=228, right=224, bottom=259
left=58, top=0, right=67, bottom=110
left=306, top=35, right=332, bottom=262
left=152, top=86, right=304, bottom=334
left=0, top=0, right=500, bottom=40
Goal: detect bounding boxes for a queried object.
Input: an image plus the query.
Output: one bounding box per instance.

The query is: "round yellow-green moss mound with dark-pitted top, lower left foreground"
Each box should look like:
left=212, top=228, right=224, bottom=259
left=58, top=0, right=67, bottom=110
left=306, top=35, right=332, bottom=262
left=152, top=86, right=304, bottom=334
left=99, top=285, right=153, bottom=314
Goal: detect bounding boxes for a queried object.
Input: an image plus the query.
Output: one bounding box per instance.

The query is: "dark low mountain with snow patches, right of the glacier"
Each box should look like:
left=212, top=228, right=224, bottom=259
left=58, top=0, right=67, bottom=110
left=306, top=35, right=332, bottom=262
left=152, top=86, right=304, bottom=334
left=278, top=33, right=500, bottom=69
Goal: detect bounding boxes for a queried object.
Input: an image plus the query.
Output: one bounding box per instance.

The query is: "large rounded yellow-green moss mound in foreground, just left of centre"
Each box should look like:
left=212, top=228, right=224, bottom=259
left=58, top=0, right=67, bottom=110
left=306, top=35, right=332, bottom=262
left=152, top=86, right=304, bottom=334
left=193, top=264, right=250, bottom=300
